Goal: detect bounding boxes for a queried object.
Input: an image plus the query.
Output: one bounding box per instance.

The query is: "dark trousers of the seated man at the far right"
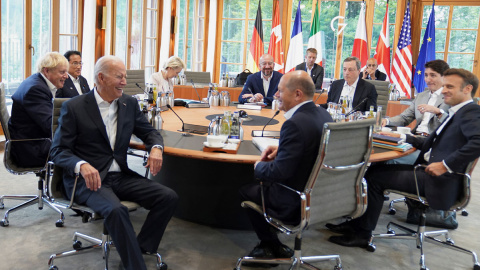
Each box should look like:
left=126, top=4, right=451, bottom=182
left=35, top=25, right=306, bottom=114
left=352, top=164, right=461, bottom=233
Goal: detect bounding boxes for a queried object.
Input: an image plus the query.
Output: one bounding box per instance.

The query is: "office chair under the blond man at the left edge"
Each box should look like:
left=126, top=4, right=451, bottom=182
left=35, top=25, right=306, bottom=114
left=0, top=83, right=65, bottom=227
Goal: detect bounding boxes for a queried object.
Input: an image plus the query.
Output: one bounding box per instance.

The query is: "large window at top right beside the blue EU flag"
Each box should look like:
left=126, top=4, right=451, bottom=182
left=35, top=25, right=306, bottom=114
left=420, top=5, right=480, bottom=71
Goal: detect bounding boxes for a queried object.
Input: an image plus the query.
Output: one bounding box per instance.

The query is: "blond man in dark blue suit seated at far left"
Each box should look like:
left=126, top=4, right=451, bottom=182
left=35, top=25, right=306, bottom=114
left=8, top=52, right=68, bottom=168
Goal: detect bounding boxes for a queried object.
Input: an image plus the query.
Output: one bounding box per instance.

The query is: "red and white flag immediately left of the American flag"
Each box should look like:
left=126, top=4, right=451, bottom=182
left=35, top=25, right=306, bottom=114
left=373, top=2, right=390, bottom=81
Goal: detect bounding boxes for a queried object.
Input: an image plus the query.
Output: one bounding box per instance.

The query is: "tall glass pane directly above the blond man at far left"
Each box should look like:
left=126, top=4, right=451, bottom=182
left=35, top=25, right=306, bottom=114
left=32, top=0, right=52, bottom=68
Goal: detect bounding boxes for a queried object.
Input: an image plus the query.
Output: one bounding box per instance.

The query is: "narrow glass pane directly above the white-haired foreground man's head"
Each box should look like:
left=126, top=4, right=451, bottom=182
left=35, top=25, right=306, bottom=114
left=115, top=0, right=127, bottom=63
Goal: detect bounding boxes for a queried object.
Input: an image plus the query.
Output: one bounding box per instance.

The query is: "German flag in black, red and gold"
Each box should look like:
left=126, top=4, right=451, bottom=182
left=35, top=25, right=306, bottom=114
left=247, top=1, right=265, bottom=73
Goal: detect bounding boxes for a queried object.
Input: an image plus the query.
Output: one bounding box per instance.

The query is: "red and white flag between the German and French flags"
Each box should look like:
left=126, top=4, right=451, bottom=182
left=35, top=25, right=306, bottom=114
left=268, top=1, right=285, bottom=73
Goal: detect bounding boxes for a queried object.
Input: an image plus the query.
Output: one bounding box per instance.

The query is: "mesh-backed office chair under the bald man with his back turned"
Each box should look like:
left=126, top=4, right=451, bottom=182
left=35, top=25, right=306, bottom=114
left=235, top=119, right=375, bottom=270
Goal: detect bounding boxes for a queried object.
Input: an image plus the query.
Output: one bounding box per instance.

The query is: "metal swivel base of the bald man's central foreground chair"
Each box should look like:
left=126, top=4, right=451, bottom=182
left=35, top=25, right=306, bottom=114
left=233, top=235, right=343, bottom=270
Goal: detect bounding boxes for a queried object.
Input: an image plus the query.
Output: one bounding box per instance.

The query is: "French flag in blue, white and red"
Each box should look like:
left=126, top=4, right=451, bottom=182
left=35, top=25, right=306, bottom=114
left=285, top=1, right=303, bottom=72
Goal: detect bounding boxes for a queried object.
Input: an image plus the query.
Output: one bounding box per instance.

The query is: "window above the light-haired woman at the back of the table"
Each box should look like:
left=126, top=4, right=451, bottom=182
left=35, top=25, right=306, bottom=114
left=175, top=0, right=207, bottom=71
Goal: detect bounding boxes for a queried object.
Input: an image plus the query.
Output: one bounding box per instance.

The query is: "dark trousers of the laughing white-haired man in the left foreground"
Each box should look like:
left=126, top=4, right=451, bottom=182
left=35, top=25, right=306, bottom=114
left=78, top=173, right=178, bottom=270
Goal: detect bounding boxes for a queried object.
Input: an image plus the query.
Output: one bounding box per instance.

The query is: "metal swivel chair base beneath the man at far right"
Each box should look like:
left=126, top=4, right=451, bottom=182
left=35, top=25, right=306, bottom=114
left=367, top=210, right=480, bottom=270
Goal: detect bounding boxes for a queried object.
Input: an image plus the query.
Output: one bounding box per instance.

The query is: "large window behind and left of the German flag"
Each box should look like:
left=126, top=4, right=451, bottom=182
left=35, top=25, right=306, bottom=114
left=217, top=0, right=273, bottom=77
